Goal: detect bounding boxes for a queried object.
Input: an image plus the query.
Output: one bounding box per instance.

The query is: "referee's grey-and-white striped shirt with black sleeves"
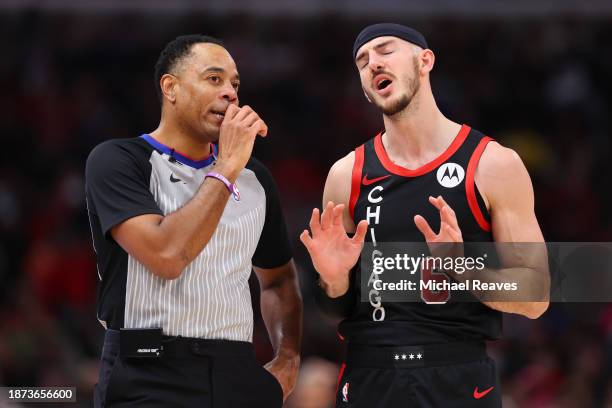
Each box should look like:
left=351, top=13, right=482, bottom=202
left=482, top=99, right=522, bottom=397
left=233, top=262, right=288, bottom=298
left=86, top=135, right=291, bottom=341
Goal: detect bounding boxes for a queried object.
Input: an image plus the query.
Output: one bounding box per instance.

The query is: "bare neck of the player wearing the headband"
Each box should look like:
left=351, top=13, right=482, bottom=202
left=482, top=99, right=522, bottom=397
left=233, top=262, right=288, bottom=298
left=383, top=92, right=461, bottom=168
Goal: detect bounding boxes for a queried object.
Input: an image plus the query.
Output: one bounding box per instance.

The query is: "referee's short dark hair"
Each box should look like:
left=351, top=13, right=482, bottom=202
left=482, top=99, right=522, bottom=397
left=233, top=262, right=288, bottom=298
left=153, top=34, right=225, bottom=103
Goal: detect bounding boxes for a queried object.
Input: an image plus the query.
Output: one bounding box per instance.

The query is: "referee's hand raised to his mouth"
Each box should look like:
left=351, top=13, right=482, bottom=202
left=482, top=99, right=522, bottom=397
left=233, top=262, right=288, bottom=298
left=215, top=104, right=268, bottom=183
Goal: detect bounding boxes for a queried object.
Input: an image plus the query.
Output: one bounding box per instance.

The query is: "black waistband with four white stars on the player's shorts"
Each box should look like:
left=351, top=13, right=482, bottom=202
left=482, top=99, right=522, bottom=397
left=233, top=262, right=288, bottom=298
left=346, top=342, right=487, bottom=368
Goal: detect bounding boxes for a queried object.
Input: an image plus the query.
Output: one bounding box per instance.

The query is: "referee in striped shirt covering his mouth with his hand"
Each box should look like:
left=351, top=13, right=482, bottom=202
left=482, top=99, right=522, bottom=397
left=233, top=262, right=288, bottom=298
left=86, top=35, right=302, bottom=408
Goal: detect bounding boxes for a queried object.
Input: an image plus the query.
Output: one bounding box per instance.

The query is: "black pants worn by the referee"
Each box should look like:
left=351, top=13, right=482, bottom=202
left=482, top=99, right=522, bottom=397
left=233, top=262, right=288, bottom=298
left=94, top=330, right=283, bottom=408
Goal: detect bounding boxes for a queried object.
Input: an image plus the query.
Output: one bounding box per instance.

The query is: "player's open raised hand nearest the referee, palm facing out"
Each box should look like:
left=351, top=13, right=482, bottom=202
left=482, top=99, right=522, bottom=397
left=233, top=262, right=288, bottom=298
left=300, top=201, right=368, bottom=294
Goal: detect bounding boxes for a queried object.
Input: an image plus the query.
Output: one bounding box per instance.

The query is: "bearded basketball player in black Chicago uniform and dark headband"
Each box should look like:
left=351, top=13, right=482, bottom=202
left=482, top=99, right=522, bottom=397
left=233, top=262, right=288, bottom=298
left=300, top=24, right=549, bottom=408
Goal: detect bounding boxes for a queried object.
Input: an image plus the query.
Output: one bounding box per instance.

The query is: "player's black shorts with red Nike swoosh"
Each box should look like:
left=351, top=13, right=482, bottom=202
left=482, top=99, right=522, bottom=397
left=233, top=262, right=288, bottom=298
left=336, top=342, right=501, bottom=408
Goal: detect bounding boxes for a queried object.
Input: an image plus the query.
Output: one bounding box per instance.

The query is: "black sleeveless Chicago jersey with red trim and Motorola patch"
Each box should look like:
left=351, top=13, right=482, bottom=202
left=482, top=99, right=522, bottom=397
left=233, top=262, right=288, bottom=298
left=339, top=125, right=501, bottom=345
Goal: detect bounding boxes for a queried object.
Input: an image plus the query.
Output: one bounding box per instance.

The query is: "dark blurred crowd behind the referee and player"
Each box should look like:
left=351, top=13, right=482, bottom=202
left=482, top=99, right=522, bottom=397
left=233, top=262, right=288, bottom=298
left=0, top=12, right=612, bottom=408
